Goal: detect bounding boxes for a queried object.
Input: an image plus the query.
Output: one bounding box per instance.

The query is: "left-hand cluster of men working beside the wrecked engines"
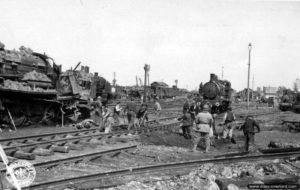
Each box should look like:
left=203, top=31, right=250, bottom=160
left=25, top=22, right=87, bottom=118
left=86, top=96, right=161, bottom=133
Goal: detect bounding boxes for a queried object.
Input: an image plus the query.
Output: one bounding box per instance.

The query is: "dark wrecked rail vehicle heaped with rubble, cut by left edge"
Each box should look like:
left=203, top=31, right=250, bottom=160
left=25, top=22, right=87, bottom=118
left=0, top=44, right=61, bottom=125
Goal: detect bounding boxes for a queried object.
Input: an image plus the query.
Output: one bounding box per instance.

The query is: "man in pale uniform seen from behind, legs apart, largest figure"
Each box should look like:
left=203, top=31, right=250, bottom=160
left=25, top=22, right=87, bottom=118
left=193, top=104, right=213, bottom=153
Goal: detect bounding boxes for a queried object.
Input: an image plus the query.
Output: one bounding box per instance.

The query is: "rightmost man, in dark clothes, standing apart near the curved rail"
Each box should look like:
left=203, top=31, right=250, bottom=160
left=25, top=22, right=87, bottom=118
left=240, top=115, right=260, bottom=151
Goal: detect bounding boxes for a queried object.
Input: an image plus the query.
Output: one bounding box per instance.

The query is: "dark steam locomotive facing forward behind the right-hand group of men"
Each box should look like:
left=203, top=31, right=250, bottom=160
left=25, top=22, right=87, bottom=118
left=199, top=73, right=232, bottom=113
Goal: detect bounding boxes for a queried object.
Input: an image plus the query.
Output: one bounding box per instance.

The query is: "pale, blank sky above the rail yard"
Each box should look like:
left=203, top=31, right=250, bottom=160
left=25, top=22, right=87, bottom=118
left=0, top=0, right=300, bottom=90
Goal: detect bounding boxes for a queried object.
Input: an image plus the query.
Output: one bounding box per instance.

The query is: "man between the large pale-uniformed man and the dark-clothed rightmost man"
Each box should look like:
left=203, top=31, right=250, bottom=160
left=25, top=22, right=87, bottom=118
left=223, top=107, right=236, bottom=144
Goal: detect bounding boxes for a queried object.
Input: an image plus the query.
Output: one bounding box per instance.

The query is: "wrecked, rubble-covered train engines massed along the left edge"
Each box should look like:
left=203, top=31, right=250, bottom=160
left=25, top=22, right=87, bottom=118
left=0, top=42, right=111, bottom=125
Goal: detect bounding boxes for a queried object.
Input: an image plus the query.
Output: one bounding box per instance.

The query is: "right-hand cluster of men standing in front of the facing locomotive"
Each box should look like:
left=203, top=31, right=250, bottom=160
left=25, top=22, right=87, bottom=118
left=178, top=100, right=260, bottom=153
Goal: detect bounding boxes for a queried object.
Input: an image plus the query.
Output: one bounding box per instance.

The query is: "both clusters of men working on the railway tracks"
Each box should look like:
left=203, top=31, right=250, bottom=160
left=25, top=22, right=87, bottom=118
left=85, top=97, right=260, bottom=153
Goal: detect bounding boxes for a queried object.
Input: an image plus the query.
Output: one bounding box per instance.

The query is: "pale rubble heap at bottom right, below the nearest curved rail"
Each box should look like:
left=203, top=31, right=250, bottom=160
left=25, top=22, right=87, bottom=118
left=110, top=162, right=296, bottom=190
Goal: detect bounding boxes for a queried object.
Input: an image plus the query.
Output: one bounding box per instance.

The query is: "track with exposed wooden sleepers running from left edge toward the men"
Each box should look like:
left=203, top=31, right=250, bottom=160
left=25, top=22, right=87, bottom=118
left=0, top=118, right=179, bottom=160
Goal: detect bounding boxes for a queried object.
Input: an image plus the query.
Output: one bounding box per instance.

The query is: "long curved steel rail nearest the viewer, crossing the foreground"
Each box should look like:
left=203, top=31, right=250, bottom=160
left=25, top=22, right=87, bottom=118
left=24, top=151, right=300, bottom=190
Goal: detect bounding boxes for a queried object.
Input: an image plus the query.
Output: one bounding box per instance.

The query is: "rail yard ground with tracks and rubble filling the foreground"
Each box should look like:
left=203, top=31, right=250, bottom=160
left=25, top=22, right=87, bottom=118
left=0, top=100, right=300, bottom=190
